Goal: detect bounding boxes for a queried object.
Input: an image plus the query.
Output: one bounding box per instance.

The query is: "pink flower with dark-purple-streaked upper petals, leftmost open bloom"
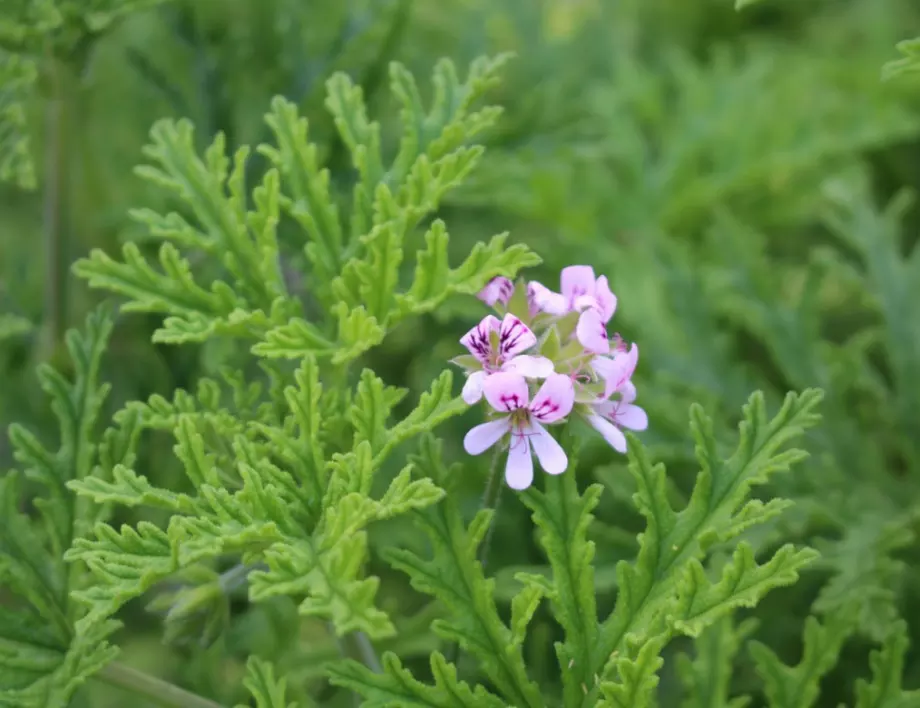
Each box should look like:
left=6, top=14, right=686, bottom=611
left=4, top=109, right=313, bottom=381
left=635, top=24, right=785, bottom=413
left=460, top=314, right=553, bottom=405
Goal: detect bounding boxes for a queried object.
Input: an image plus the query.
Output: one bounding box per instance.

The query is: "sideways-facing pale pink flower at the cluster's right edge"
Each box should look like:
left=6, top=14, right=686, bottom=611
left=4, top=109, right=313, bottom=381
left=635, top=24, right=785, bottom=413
left=585, top=344, right=648, bottom=452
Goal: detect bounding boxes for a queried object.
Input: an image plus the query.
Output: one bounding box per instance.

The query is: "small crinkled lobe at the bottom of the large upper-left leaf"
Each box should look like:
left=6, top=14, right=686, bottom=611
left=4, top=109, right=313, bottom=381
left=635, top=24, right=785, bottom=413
left=252, top=303, right=384, bottom=365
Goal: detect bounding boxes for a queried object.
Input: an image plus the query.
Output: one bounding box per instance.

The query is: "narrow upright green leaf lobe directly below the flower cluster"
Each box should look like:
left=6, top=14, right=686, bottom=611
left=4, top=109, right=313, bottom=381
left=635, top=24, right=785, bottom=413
left=521, top=474, right=603, bottom=704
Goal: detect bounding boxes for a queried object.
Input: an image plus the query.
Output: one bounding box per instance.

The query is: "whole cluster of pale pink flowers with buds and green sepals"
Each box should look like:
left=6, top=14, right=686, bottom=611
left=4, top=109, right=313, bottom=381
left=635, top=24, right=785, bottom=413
left=453, top=266, right=648, bottom=489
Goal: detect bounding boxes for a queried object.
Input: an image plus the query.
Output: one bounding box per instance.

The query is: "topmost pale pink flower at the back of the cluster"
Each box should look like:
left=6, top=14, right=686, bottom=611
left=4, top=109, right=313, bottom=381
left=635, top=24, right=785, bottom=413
left=527, top=266, right=617, bottom=354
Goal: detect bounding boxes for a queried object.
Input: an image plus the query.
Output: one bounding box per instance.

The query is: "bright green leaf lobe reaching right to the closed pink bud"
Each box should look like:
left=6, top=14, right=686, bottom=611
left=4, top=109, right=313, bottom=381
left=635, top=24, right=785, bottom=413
left=393, top=224, right=541, bottom=320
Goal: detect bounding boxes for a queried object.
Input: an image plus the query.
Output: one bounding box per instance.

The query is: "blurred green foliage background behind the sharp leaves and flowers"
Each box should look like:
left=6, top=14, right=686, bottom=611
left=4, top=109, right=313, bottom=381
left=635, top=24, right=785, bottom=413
left=0, top=0, right=920, bottom=708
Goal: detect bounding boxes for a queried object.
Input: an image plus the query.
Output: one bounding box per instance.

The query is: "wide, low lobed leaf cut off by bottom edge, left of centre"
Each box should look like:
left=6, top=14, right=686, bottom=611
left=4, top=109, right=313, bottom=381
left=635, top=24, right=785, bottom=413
left=326, top=652, right=507, bottom=708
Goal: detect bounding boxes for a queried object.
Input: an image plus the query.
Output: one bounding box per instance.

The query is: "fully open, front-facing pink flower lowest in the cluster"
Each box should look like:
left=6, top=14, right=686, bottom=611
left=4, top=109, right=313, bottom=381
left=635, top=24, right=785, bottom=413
left=463, top=372, right=575, bottom=489
